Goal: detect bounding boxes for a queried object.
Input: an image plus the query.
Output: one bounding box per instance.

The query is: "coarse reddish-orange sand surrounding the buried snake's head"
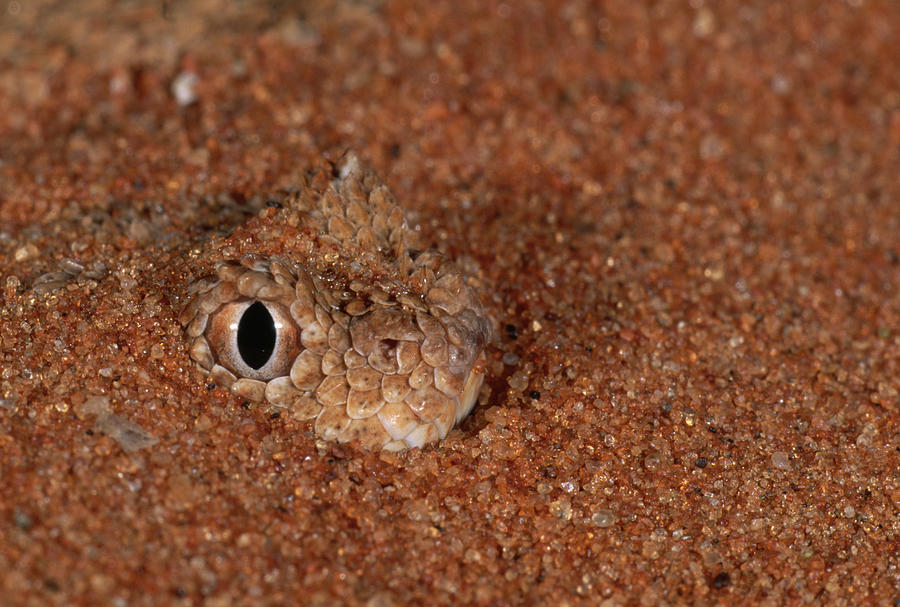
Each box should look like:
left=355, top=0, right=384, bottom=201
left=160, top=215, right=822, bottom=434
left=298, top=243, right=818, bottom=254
left=0, top=0, right=900, bottom=606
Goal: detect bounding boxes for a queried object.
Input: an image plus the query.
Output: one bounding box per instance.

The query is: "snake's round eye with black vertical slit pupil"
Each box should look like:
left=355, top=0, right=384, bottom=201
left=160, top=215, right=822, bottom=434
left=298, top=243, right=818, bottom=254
left=206, top=299, right=301, bottom=381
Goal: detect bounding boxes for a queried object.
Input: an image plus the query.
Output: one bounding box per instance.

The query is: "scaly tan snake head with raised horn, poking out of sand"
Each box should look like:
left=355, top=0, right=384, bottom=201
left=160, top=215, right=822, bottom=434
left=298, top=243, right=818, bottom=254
left=179, top=152, right=493, bottom=451
